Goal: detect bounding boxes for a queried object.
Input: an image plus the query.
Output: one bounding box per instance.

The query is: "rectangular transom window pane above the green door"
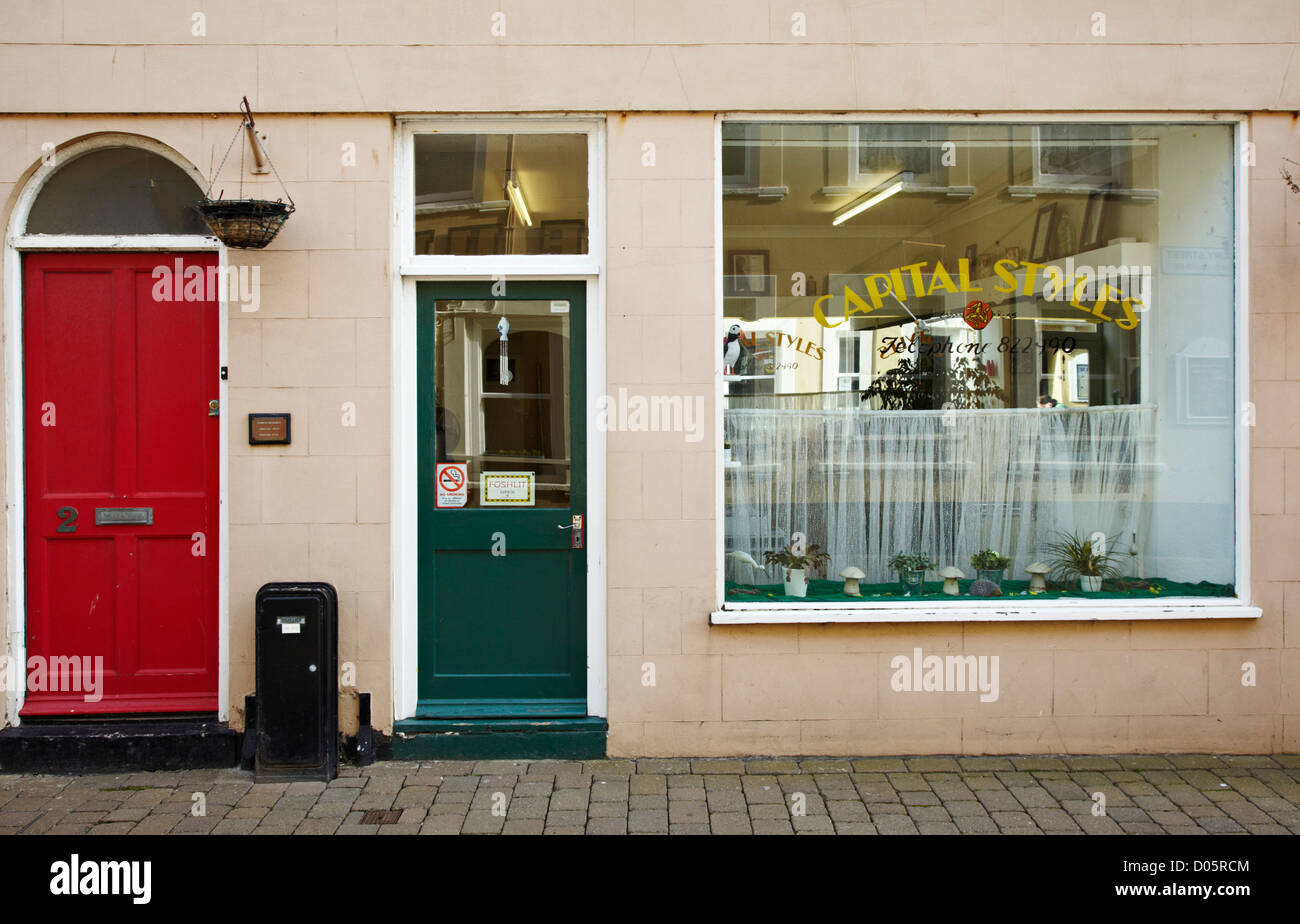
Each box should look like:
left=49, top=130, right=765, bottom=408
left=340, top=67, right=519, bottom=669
left=412, top=131, right=588, bottom=256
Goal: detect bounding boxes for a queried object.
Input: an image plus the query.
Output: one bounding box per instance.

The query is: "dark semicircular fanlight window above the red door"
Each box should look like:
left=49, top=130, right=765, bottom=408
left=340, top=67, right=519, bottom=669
left=26, top=147, right=211, bottom=235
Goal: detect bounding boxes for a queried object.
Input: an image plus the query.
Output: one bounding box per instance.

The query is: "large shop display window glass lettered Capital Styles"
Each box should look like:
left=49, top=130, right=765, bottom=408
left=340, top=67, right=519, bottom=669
left=720, top=122, right=1238, bottom=606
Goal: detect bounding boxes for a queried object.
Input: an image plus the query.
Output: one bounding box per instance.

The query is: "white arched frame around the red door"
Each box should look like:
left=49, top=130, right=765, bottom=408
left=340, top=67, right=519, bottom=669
left=0, top=133, right=230, bottom=725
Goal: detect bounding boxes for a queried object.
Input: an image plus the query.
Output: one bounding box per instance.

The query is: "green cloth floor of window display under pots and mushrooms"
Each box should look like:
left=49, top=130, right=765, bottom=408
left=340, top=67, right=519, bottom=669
left=727, top=577, right=1236, bottom=603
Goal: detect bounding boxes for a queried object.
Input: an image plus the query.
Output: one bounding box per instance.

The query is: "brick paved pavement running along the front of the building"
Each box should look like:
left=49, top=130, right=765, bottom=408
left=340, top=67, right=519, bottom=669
left=0, top=754, right=1300, bottom=834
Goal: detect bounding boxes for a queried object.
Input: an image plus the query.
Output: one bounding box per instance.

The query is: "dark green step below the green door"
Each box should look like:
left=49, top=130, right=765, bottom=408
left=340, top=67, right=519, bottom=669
left=393, top=716, right=610, bottom=760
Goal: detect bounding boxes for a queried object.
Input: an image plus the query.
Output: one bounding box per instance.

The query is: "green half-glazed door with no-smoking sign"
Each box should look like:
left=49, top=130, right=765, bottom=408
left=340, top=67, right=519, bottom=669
left=416, top=282, right=586, bottom=719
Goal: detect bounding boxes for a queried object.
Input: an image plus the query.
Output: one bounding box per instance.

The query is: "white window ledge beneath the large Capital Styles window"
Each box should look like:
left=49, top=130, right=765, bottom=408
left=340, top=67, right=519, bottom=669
left=709, top=599, right=1261, bottom=625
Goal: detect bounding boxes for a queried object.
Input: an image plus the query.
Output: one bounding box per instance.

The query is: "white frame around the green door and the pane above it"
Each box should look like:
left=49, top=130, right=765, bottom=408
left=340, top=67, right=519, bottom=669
left=390, top=116, right=608, bottom=720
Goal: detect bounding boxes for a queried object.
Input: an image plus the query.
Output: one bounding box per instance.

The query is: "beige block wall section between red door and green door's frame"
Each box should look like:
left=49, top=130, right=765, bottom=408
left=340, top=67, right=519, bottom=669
left=0, top=115, right=393, bottom=732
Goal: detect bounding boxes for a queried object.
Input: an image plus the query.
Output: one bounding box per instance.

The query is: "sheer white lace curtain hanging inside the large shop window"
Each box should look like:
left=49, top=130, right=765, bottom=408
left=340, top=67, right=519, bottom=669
left=724, top=392, right=1156, bottom=582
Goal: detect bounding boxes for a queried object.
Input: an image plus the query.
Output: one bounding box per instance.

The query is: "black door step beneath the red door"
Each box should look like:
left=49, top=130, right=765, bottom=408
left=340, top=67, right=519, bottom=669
left=0, top=720, right=243, bottom=773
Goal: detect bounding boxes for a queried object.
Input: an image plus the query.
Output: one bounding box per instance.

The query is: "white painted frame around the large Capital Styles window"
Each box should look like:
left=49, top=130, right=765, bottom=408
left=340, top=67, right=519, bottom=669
left=710, top=112, right=1260, bottom=625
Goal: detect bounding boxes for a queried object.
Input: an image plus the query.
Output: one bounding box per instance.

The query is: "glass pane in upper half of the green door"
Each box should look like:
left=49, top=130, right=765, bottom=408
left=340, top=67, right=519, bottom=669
left=434, top=299, right=571, bottom=507
